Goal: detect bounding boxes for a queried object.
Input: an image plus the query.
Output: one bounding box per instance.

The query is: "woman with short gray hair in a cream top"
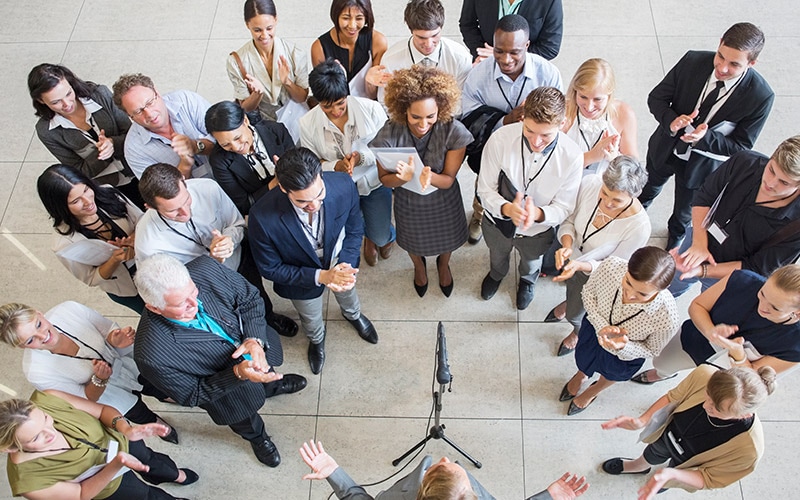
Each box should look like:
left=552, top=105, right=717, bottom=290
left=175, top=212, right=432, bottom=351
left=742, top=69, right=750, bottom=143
left=545, top=155, right=650, bottom=356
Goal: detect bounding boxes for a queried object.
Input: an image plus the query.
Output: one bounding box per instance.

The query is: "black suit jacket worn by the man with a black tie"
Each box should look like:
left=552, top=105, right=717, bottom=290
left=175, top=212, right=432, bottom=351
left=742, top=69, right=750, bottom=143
left=647, top=51, right=775, bottom=189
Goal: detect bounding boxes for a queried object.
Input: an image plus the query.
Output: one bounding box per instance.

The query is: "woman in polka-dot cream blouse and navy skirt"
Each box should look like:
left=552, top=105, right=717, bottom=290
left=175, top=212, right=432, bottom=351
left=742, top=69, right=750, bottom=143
left=558, top=247, right=680, bottom=415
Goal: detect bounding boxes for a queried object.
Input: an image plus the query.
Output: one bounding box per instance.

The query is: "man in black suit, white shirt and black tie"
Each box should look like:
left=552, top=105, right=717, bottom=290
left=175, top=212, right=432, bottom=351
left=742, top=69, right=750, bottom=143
left=639, top=23, right=775, bottom=250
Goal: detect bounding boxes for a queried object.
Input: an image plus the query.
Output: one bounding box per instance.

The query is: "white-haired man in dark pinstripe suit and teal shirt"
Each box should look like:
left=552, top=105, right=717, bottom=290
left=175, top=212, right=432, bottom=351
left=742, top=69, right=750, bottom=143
left=133, top=254, right=306, bottom=467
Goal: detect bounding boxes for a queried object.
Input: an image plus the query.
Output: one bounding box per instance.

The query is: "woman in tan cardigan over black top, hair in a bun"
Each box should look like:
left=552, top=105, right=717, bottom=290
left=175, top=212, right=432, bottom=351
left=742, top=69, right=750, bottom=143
left=602, top=365, right=775, bottom=500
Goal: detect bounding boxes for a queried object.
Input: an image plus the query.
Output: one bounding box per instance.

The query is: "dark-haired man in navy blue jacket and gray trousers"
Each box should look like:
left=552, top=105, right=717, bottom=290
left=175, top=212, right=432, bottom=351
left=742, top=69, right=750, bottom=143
left=248, top=148, right=378, bottom=374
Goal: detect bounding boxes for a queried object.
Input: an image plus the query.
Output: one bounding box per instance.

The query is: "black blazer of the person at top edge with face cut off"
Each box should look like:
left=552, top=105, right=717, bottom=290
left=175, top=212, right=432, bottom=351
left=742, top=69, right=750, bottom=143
left=458, top=0, right=564, bottom=60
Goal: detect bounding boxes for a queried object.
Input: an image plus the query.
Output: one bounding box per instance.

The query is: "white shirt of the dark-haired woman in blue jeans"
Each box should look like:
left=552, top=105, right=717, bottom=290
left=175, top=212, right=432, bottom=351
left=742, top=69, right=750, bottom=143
left=300, top=96, right=388, bottom=196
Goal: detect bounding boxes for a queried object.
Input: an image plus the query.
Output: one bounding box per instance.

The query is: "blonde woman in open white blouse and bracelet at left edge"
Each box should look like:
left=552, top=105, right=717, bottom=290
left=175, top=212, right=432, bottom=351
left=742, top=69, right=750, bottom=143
left=0, top=301, right=178, bottom=444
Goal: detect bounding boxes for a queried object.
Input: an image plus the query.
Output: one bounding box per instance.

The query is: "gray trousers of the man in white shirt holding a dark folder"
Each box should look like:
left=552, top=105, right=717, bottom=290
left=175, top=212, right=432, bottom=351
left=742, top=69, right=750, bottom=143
left=481, top=217, right=555, bottom=283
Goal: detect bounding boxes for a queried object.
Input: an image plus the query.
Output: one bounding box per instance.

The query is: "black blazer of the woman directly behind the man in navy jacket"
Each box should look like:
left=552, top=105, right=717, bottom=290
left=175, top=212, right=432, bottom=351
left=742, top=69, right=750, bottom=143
left=208, top=120, right=294, bottom=215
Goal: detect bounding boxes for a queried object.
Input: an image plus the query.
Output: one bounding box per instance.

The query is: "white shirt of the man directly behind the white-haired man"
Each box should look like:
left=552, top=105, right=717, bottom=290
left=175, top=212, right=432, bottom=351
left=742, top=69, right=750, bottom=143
left=134, top=179, right=244, bottom=271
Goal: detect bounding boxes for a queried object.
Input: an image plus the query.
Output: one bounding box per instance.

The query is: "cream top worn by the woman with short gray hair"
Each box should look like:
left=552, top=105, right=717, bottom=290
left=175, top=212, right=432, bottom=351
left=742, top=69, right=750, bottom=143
left=558, top=174, right=650, bottom=272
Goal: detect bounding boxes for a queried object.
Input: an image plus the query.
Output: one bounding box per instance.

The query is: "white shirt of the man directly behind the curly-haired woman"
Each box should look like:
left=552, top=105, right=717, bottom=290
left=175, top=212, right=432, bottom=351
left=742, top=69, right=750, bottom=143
left=378, top=35, right=472, bottom=104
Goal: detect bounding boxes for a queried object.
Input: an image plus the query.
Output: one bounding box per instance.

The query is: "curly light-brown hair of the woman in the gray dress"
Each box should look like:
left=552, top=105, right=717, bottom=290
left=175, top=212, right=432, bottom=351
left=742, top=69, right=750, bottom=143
left=384, top=64, right=461, bottom=124
